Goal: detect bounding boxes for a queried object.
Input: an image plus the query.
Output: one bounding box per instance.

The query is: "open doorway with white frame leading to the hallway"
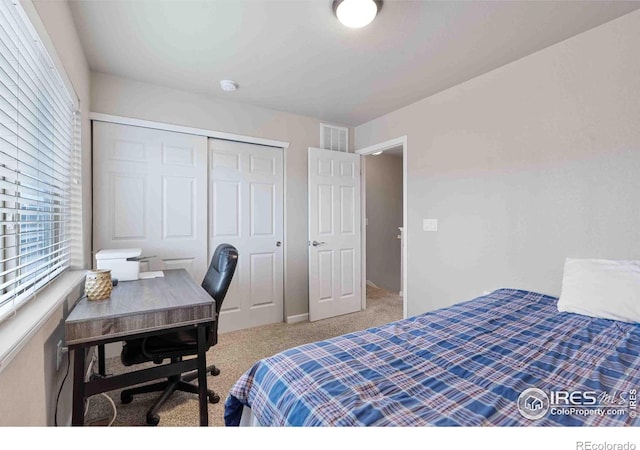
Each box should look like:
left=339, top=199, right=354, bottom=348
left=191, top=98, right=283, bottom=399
left=356, top=136, right=407, bottom=317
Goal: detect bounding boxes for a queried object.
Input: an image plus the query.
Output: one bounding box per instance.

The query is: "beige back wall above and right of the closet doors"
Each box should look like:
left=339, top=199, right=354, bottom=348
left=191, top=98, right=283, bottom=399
left=91, top=73, right=344, bottom=317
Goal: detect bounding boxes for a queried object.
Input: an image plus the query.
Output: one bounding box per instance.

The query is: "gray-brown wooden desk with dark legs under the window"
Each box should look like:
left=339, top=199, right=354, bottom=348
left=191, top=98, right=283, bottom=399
left=65, top=269, right=216, bottom=426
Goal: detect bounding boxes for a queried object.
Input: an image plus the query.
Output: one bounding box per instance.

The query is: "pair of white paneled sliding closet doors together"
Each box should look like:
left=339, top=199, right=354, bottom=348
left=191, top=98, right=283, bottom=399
left=93, top=121, right=284, bottom=332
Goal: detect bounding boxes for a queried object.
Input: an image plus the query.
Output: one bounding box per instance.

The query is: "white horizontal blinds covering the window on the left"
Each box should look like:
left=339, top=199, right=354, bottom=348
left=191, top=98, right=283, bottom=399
left=0, top=0, right=78, bottom=320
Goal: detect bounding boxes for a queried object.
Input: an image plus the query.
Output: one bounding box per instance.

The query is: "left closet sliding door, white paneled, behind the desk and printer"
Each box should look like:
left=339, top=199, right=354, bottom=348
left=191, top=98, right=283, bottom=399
left=93, top=122, right=209, bottom=282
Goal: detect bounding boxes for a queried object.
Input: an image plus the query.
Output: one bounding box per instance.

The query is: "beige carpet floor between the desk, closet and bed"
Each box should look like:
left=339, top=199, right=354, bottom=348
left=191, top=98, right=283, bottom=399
left=85, top=286, right=402, bottom=427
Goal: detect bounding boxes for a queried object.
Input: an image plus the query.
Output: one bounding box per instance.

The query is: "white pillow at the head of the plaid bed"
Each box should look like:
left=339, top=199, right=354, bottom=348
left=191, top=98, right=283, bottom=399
left=558, top=258, right=640, bottom=323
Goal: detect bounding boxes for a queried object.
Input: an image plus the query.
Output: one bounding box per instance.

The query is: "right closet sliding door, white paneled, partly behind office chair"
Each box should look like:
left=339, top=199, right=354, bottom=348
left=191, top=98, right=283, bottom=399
left=209, top=139, right=284, bottom=331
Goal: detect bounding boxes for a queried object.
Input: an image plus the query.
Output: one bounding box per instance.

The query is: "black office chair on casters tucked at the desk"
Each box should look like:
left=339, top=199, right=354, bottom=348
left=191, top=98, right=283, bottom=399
left=120, top=244, right=238, bottom=425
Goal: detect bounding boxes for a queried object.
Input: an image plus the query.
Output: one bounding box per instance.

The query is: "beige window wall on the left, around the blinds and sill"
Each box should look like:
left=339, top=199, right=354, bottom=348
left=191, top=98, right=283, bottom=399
left=0, top=1, right=91, bottom=426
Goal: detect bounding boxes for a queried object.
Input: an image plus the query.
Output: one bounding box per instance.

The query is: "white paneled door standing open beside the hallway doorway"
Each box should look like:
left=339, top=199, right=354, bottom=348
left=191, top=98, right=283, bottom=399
left=309, top=148, right=362, bottom=321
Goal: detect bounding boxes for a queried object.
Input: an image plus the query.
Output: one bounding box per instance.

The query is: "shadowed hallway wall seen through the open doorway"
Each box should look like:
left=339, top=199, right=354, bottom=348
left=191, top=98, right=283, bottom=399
left=364, top=153, right=402, bottom=294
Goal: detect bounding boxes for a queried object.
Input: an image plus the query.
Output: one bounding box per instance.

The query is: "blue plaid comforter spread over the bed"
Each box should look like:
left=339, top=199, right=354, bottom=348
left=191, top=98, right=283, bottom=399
left=225, top=289, right=640, bottom=426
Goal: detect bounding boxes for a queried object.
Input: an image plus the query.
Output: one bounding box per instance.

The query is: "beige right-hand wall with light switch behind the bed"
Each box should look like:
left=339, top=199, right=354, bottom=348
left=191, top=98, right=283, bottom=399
left=355, top=12, right=640, bottom=315
